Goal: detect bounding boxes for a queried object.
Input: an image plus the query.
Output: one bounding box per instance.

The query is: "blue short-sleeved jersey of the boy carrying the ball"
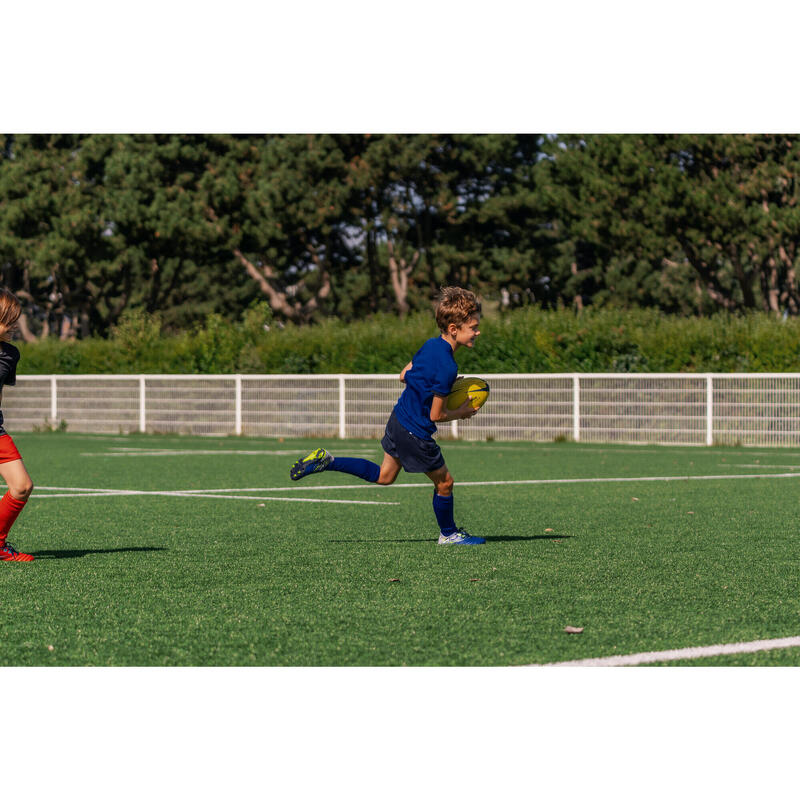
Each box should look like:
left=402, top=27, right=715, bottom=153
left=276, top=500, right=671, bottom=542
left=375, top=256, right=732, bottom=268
left=394, top=336, right=458, bottom=439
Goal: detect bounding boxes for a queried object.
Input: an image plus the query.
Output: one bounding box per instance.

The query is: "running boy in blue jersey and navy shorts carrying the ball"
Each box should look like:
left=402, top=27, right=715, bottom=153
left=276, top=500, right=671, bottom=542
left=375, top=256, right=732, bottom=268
left=289, top=286, right=486, bottom=544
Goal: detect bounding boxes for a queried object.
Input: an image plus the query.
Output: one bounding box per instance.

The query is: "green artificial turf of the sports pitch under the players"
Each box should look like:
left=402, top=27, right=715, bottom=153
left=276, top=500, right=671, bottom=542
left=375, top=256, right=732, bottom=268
left=0, top=433, right=800, bottom=666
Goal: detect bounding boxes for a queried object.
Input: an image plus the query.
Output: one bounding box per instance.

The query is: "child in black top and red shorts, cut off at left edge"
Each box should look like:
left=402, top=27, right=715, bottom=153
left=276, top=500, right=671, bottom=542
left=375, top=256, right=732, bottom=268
left=0, top=289, right=33, bottom=561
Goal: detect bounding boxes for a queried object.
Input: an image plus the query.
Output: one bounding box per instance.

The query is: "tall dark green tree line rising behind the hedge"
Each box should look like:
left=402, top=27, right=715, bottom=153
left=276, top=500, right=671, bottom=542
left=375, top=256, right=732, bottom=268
left=0, top=134, right=800, bottom=339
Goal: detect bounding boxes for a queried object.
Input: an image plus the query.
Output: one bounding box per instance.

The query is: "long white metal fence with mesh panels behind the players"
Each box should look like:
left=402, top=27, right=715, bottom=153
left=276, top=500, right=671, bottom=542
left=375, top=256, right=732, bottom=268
left=2, top=373, right=800, bottom=445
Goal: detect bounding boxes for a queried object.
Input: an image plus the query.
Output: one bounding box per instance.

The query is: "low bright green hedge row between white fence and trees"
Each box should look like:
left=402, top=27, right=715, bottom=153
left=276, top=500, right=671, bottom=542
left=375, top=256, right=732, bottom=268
left=18, top=309, right=800, bottom=374
